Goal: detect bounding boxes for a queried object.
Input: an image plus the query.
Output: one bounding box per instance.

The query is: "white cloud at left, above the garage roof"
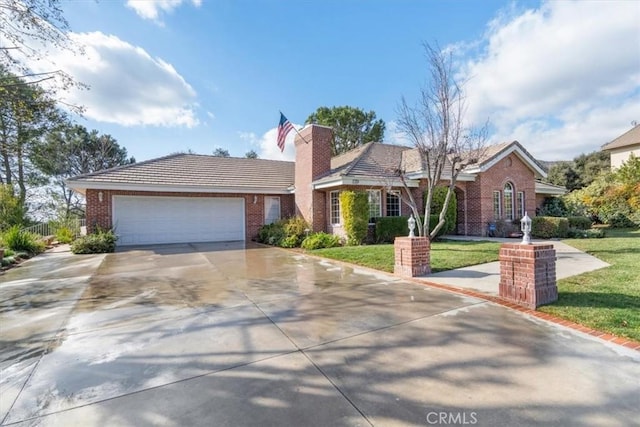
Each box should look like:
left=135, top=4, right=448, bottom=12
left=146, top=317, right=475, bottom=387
left=30, top=32, right=198, bottom=127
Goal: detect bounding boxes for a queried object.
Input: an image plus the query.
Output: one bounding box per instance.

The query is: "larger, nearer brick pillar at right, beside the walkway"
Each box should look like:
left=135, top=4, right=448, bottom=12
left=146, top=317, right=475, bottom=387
left=500, top=243, right=558, bottom=310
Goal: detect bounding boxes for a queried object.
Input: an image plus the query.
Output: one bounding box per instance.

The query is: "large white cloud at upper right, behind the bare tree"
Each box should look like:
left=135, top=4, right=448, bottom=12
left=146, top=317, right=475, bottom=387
left=454, top=1, right=640, bottom=160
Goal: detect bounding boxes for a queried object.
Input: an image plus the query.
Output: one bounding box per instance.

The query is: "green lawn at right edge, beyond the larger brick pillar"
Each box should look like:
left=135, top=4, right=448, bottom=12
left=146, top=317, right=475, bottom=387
left=539, top=230, right=640, bottom=341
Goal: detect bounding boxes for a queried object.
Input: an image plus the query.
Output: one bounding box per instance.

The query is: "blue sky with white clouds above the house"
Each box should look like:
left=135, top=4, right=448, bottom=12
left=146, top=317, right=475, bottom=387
left=17, top=0, right=640, bottom=161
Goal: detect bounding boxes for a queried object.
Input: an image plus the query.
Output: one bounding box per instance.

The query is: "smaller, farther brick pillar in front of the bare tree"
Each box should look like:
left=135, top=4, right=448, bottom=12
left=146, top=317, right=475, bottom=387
left=393, top=237, right=431, bottom=277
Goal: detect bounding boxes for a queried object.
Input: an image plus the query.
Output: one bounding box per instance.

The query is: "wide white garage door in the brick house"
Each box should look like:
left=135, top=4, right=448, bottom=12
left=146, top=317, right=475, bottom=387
left=113, top=196, right=245, bottom=245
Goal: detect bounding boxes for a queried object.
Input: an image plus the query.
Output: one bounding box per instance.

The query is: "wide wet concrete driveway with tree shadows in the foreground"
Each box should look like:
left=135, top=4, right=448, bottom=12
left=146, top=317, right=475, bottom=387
left=0, top=243, right=640, bottom=426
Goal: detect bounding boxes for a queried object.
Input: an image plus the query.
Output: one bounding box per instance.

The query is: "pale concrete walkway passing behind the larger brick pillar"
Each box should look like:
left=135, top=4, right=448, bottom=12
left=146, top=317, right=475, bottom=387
left=420, top=236, right=609, bottom=295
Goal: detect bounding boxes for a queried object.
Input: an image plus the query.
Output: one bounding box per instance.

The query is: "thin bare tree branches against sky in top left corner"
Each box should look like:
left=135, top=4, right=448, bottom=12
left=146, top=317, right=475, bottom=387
left=0, top=0, right=86, bottom=101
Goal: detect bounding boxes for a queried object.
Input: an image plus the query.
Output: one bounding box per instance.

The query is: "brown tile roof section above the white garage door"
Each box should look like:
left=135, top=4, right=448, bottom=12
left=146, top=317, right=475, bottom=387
left=67, top=154, right=294, bottom=194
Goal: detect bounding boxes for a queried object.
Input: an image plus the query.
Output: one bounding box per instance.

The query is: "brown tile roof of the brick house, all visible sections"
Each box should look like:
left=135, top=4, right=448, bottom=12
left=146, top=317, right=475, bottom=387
left=67, top=141, right=535, bottom=191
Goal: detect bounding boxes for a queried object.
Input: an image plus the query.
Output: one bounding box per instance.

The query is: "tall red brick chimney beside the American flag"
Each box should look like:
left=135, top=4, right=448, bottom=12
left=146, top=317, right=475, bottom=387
left=294, top=124, right=333, bottom=231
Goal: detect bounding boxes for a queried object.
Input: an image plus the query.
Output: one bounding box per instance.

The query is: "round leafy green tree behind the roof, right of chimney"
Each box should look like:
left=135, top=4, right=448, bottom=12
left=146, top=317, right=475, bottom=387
left=305, top=105, right=385, bottom=156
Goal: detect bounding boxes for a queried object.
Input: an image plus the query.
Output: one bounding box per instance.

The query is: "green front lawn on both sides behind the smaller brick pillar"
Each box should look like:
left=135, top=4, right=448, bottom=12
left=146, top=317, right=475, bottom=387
left=310, top=240, right=500, bottom=273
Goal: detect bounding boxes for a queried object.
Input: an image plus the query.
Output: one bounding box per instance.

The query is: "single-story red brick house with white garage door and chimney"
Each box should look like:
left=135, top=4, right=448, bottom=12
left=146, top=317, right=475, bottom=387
left=68, top=125, right=560, bottom=245
